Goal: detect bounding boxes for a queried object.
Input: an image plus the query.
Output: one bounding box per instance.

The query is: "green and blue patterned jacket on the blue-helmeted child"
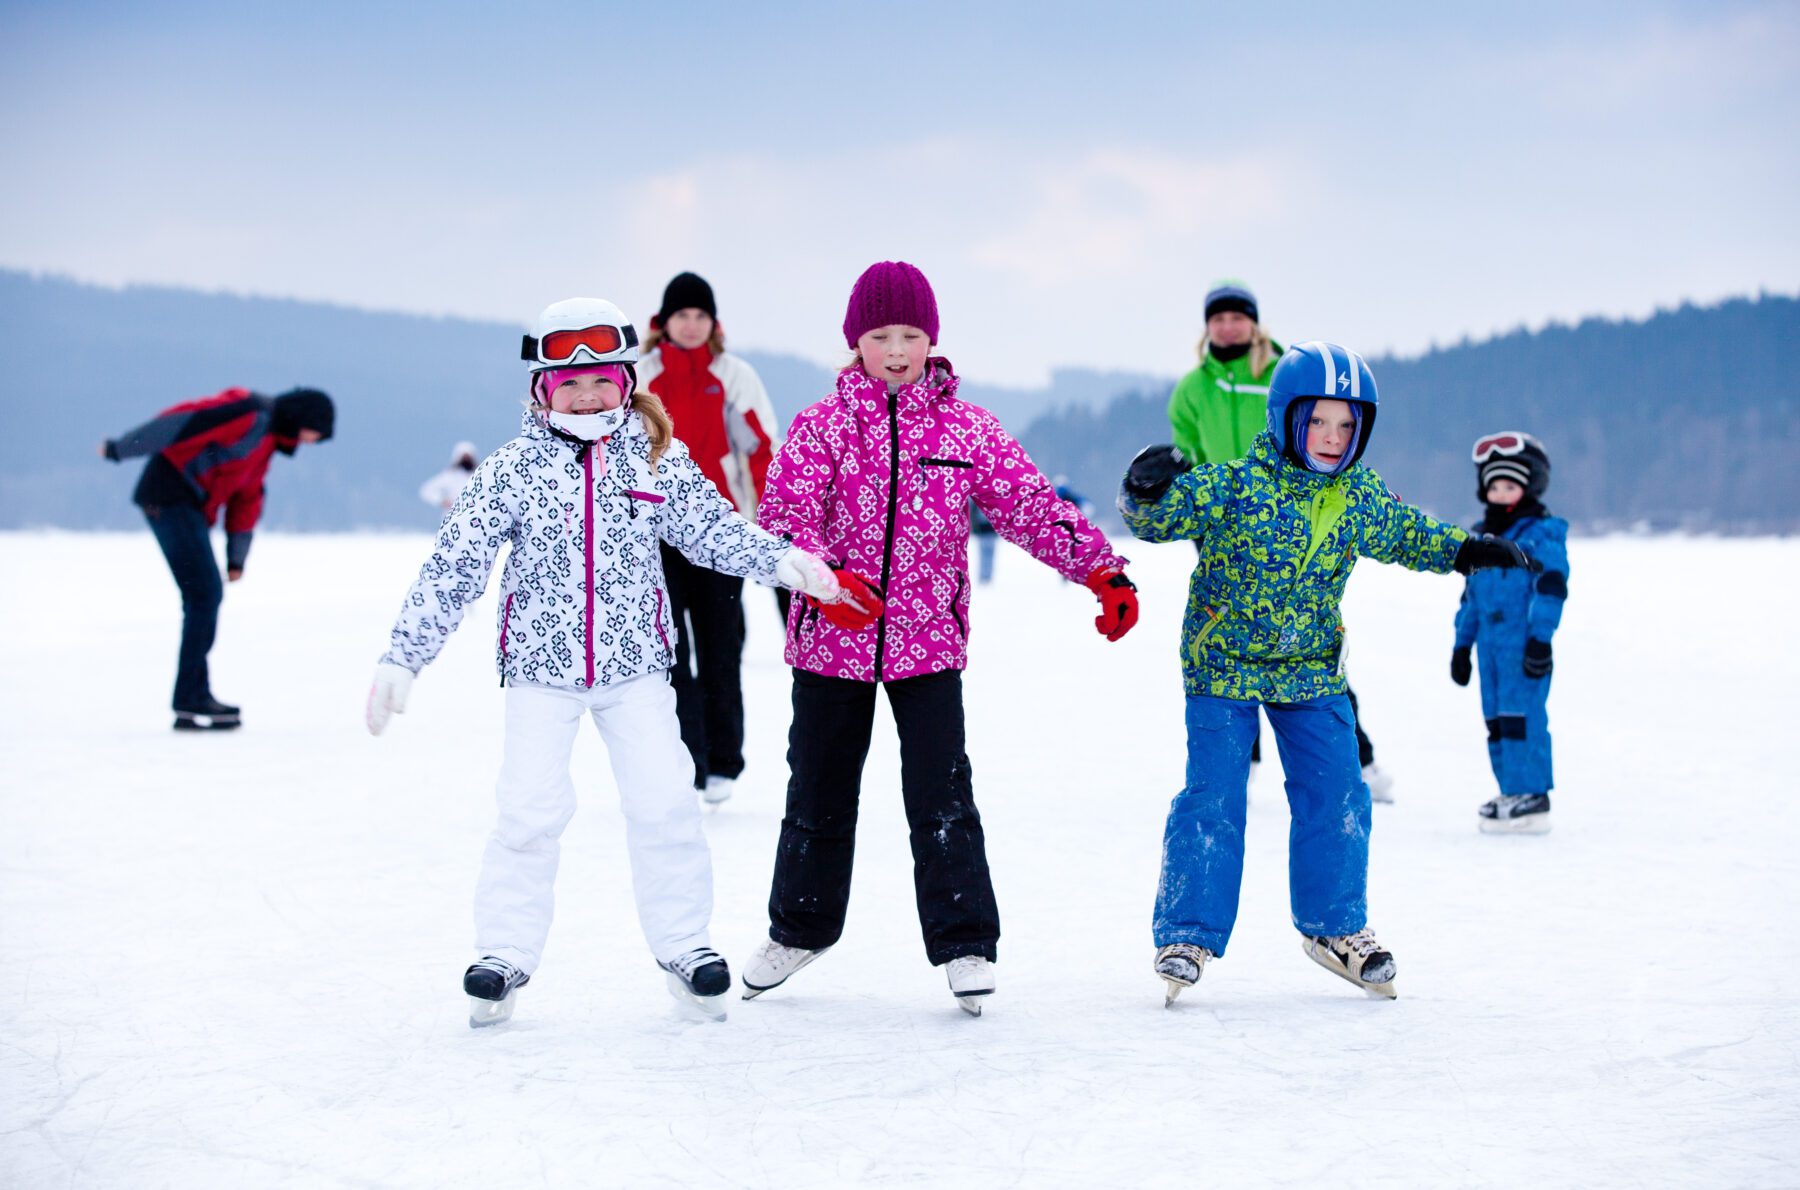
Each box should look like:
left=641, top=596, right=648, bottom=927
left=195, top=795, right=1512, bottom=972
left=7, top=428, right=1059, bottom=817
left=1120, top=432, right=1469, bottom=702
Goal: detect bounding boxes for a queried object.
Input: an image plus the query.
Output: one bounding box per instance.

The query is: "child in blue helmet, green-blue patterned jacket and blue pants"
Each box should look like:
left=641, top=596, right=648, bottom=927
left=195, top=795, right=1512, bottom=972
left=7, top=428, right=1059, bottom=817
left=1120, top=342, right=1526, bottom=1003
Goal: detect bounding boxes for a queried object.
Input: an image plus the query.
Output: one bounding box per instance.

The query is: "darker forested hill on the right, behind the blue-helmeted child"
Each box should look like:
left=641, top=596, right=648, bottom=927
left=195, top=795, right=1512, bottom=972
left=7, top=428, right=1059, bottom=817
left=1022, top=295, right=1800, bottom=533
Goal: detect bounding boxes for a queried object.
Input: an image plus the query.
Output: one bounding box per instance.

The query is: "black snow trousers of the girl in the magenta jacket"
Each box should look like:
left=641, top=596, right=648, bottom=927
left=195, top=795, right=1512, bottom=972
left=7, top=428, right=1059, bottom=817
left=769, top=670, right=1001, bottom=965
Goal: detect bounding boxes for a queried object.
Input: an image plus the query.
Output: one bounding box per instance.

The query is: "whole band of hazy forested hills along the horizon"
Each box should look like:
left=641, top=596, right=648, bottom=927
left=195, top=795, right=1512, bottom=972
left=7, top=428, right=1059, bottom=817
left=0, top=270, right=1800, bottom=531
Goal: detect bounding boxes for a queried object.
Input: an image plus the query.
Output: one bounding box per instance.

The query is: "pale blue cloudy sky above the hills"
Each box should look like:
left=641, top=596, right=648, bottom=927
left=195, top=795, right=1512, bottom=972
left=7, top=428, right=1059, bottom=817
left=0, top=0, right=1800, bottom=383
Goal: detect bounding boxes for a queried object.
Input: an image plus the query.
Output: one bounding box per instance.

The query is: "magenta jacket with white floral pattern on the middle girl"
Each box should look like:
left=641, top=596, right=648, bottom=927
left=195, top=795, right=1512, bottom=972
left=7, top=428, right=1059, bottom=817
left=758, top=358, right=1125, bottom=682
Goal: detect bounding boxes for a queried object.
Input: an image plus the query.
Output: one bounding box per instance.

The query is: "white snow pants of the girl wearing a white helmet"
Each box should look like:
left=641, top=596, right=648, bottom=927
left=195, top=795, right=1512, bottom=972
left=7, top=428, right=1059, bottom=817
left=475, top=673, right=713, bottom=974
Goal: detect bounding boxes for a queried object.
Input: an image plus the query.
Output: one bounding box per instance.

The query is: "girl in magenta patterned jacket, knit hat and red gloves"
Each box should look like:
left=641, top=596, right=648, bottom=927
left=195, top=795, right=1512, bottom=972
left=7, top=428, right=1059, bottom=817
left=743, top=261, right=1138, bottom=1014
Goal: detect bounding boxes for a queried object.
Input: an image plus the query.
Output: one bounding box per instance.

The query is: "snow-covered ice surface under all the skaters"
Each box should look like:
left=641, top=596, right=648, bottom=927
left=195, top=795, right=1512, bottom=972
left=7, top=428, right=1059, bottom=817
left=0, top=533, right=1800, bottom=1190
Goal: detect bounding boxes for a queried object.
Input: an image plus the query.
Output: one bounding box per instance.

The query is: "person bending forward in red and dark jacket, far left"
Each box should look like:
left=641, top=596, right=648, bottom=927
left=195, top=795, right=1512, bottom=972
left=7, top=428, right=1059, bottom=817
left=101, top=389, right=337, bottom=727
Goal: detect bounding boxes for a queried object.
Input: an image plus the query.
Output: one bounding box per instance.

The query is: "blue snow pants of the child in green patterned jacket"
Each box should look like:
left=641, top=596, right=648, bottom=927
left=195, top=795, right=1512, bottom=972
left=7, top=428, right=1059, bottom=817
left=1152, top=695, right=1370, bottom=956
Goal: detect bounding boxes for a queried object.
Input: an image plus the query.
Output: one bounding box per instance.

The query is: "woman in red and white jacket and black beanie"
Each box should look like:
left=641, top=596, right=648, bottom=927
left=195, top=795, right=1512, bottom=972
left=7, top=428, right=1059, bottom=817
left=637, top=272, right=787, bottom=803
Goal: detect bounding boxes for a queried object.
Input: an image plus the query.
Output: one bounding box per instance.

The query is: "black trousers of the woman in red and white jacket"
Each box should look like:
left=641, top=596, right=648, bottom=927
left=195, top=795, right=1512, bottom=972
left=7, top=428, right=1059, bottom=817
left=662, top=545, right=743, bottom=789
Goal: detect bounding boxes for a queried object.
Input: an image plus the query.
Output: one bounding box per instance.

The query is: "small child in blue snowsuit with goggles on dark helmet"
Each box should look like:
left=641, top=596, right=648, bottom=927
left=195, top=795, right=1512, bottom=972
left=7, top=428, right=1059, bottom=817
left=1451, top=430, right=1570, bottom=834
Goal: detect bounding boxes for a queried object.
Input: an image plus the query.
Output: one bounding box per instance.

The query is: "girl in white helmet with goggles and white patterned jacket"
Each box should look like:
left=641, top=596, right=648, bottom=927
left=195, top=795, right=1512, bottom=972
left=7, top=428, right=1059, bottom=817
left=367, top=297, right=839, bottom=1026
